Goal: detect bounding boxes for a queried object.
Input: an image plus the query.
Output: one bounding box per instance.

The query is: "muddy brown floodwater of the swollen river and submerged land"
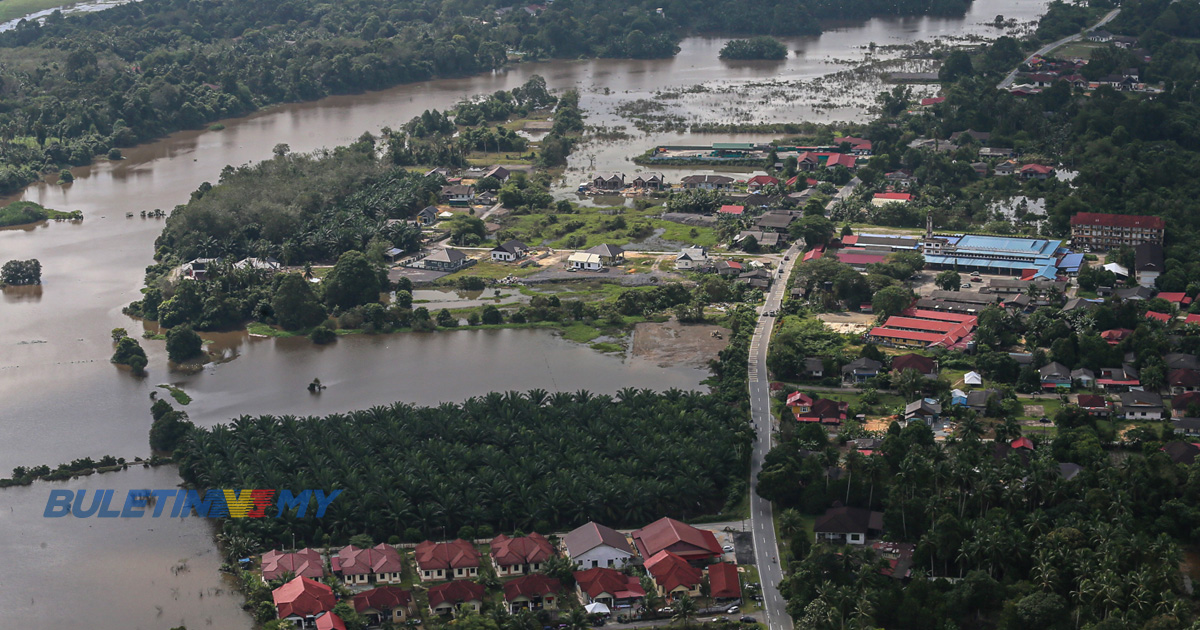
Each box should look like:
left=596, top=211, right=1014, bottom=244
left=0, top=0, right=1045, bottom=629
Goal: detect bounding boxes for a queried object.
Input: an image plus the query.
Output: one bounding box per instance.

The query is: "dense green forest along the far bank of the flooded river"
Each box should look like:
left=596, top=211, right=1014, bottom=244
left=0, top=0, right=970, bottom=193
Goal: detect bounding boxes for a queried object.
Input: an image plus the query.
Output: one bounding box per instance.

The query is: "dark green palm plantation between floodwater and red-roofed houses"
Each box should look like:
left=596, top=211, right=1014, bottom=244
left=175, top=389, right=751, bottom=544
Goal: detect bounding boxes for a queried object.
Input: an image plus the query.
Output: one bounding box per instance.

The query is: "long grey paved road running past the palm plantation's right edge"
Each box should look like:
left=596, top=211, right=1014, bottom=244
left=749, top=244, right=800, bottom=630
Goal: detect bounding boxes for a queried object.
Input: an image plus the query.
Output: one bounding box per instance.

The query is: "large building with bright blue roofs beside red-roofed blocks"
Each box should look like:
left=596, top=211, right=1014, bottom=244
left=920, top=234, right=1062, bottom=276
